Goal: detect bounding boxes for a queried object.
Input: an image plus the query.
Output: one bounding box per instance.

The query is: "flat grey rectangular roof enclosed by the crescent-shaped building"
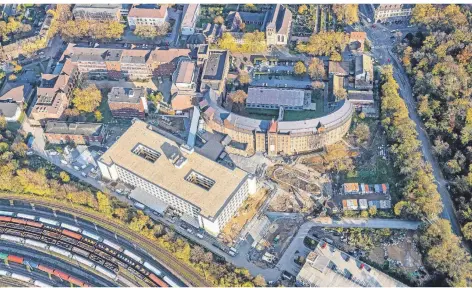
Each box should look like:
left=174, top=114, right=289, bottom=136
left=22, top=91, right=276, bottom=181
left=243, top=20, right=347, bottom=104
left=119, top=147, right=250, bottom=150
left=246, top=87, right=305, bottom=107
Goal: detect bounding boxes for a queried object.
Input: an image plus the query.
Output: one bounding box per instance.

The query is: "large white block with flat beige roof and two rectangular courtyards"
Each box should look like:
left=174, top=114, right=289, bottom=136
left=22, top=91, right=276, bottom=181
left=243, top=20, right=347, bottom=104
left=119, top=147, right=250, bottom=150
left=98, top=120, right=257, bottom=236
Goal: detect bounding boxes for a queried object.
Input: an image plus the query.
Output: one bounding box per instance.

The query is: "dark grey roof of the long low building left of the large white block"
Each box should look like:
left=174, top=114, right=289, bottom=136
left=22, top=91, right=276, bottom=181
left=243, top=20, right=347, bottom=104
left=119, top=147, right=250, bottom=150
left=44, top=121, right=102, bottom=136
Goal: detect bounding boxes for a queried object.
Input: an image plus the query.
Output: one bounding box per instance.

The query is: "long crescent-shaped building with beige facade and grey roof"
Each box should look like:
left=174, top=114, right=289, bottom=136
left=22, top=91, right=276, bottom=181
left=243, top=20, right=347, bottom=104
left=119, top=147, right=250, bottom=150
left=200, top=90, right=354, bottom=155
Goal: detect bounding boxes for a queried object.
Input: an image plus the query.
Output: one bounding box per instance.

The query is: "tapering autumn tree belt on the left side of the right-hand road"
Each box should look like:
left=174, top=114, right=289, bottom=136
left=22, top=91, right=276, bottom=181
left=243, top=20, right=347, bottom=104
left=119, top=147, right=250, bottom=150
left=381, top=66, right=442, bottom=218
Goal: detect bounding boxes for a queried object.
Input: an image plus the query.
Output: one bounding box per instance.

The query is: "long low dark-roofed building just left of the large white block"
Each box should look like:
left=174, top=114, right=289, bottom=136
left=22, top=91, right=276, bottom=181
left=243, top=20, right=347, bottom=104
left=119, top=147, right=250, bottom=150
left=44, top=121, right=105, bottom=145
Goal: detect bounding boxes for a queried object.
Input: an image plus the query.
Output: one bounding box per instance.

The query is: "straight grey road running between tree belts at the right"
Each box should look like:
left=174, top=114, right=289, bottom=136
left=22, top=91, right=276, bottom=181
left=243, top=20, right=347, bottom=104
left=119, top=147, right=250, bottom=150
left=360, top=15, right=461, bottom=236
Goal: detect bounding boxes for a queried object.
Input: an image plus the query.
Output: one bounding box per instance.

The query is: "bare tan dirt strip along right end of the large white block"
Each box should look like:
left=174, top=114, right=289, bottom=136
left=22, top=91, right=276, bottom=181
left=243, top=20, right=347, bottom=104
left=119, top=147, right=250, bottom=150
left=220, top=188, right=268, bottom=243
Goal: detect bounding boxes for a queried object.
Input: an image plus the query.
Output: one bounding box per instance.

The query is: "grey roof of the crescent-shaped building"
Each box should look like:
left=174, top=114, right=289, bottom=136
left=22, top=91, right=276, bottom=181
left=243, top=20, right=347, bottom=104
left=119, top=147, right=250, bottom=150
left=200, top=89, right=354, bottom=134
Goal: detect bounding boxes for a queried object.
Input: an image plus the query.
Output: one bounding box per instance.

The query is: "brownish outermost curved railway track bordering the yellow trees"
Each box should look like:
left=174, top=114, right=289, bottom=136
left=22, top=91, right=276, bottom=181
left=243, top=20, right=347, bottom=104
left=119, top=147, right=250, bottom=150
left=0, top=193, right=212, bottom=287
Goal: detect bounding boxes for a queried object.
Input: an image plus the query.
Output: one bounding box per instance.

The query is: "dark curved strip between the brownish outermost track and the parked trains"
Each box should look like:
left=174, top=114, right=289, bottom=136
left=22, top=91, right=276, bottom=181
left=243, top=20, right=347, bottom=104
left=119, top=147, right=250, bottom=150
left=0, top=199, right=184, bottom=286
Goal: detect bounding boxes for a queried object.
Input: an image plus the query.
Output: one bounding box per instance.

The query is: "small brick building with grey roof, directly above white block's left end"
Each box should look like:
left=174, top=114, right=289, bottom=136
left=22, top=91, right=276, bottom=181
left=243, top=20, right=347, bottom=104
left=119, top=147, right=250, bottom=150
left=108, top=87, right=147, bottom=119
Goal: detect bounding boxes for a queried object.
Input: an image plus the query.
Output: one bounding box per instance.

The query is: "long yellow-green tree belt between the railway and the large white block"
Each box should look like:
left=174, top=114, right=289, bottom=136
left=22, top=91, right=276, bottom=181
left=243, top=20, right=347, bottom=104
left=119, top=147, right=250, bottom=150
left=0, top=122, right=265, bottom=287
